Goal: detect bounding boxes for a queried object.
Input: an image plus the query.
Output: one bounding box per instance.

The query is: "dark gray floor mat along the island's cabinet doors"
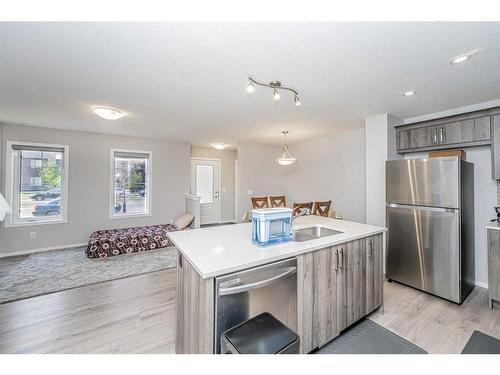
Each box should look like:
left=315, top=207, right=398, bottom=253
left=315, top=319, right=427, bottom=354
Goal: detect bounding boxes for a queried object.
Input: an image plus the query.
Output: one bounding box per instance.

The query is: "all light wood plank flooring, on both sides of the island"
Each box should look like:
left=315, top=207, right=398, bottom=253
left=0, top=269, right=500, bottom=353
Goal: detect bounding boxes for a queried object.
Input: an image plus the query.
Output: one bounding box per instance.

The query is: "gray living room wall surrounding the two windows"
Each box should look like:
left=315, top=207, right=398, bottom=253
left=0, top=124, right=190, bottom=253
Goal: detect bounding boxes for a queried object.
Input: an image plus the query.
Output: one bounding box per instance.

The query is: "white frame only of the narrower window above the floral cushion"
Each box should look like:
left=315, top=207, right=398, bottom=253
left=108, top=148, right=153, bottom=220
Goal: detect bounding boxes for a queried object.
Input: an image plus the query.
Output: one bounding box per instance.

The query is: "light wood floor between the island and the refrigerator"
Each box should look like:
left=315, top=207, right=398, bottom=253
left=369, top=282, right=500, bottom=353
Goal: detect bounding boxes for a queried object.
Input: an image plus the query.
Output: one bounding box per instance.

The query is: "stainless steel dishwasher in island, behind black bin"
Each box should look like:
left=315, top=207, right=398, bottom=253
left=214, top=258, right=297, bottom=353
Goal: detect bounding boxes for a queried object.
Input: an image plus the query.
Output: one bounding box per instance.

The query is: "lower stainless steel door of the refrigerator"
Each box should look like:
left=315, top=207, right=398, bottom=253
left=386, top=204, right=462, bottom=303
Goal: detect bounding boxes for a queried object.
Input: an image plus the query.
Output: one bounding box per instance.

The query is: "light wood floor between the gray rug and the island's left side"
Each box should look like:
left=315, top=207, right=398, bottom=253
left=0, top=269, right=176, bottom=353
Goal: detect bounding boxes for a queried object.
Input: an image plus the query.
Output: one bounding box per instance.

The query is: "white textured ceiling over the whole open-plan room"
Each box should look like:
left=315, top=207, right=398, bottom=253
left=0, top=22, right=500, bottom=145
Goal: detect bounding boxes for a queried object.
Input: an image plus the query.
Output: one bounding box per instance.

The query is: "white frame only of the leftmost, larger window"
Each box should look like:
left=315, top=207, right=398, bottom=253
left=4, top=141, right=69, bottom=228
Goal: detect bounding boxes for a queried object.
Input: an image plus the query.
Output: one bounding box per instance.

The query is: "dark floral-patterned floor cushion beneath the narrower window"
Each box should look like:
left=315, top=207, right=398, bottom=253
left=85, top=224, right=181, bottom=258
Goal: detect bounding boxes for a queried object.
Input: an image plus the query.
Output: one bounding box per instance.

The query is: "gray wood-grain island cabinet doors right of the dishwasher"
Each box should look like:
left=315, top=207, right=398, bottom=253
left=297, top=234, right=383, bottom=353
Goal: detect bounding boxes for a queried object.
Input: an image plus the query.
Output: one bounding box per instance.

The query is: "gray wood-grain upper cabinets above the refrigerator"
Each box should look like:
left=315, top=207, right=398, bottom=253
left=396, top=107, right=500, bottom=180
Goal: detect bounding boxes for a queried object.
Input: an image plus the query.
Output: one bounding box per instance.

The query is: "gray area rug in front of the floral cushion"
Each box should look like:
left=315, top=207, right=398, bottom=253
left=0, top=247, right=177, bottom=304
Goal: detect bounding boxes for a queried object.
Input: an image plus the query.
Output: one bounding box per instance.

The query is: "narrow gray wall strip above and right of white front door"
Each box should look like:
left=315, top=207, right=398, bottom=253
left=191, top=146, right=236, bottom=222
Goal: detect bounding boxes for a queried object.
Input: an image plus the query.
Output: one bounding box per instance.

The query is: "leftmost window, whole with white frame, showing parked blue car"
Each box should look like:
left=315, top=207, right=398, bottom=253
left=5, top=141, right=68, bottom=226
